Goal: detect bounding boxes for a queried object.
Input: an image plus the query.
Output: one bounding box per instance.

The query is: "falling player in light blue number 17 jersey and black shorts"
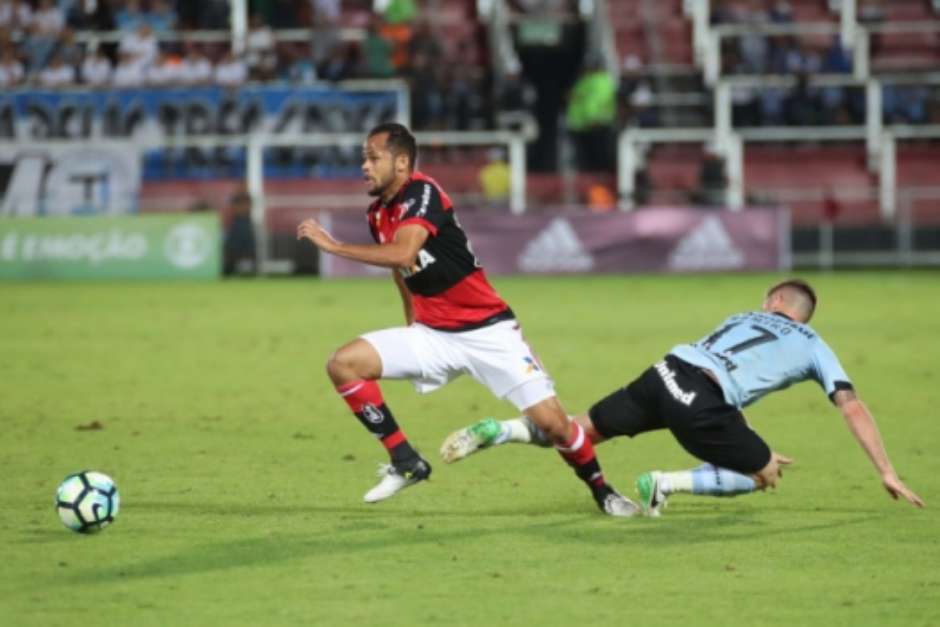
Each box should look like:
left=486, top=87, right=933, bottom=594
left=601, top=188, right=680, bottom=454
left=441, top=279, right=924, bottom=516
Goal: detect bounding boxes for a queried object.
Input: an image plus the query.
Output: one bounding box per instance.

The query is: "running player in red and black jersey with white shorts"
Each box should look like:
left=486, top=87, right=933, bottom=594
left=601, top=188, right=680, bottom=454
left=297, top=123, right=639, bottom=516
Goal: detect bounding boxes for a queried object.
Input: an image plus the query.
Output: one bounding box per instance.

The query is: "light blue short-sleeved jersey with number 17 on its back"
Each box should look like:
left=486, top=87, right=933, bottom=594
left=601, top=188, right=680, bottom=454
left=670, top=311, right=852, bottom=409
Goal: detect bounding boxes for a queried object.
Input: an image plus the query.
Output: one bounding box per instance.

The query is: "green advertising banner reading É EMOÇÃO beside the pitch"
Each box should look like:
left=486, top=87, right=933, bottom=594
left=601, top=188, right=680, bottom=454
left=0, top=214, right=222, bottom=279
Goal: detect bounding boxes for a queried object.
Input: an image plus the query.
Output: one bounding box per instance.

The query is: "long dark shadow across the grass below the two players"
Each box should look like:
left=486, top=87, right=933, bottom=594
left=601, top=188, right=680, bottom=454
left=49, top=503, right=883, bottom=585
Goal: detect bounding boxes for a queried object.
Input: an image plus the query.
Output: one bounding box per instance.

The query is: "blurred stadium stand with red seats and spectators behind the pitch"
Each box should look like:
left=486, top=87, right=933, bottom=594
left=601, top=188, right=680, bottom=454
left=0, top=0, right=940, bottom=268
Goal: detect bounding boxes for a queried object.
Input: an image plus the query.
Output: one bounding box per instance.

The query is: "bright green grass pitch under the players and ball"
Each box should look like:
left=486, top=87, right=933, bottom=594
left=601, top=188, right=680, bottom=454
left=0, top=272, right=940, bottom=627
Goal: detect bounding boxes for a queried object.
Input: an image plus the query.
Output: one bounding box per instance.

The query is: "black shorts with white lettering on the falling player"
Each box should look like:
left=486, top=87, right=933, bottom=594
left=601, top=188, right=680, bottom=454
left=589, top=355, right=770, bottom=474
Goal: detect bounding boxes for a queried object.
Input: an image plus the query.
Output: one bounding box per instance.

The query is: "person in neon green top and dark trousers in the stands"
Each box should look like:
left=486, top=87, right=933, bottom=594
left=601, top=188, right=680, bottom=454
left=566, top=59, right=617, bottom=172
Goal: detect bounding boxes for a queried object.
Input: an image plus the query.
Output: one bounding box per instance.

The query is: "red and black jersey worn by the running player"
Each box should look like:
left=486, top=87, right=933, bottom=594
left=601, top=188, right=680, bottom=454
left=367, top=172, right=512, bottom=331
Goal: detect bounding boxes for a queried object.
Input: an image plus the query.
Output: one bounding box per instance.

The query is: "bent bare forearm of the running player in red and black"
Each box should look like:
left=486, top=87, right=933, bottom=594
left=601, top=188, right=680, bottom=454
left=297, top=218, right=428, bottom=268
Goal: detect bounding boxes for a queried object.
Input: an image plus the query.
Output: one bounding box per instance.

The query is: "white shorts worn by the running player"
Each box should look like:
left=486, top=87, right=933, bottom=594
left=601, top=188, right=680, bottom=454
left=362, top=320, right=555, bottom=411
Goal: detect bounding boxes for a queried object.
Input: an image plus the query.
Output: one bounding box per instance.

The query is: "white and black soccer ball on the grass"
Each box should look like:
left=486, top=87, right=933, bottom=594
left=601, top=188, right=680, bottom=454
left=55, top=470, right=121, bottom=533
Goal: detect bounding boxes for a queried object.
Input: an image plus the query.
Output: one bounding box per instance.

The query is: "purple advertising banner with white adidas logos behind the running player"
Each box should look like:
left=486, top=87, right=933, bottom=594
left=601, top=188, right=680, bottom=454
left=320, top=208, right=790, bottom=277
